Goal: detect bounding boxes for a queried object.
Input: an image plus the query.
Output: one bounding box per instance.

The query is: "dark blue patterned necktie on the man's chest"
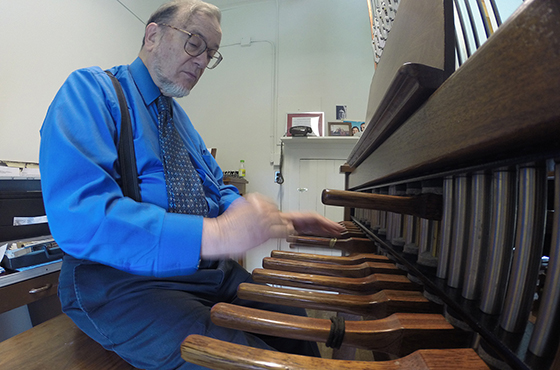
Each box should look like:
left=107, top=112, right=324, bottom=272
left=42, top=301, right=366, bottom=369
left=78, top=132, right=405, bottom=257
left=157, top=95, right=208, bottom=216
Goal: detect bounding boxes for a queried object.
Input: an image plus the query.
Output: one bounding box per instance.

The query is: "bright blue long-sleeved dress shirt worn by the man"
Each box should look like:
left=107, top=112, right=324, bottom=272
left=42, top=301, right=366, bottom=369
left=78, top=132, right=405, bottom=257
left=39, top=58, right=239, bottom=277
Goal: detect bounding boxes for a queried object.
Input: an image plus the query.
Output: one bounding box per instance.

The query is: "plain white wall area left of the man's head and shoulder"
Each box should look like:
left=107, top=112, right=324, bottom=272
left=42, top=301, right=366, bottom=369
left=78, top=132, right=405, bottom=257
left=0, top=0, right=152, bottom=162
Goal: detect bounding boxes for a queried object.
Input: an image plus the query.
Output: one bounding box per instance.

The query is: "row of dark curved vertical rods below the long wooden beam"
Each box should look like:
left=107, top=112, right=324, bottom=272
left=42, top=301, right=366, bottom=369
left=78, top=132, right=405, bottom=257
left=346, top=160, right=560, bottom=370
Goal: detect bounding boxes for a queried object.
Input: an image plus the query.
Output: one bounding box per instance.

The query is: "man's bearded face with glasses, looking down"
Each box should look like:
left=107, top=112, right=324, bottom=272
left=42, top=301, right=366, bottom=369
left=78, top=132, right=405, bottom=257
left=153, top=14, right=222, bottom=97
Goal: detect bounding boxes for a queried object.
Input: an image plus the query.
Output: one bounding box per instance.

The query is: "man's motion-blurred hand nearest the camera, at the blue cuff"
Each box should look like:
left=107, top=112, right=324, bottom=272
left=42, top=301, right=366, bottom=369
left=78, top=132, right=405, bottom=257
left=200, top=194, right=288, bottom=258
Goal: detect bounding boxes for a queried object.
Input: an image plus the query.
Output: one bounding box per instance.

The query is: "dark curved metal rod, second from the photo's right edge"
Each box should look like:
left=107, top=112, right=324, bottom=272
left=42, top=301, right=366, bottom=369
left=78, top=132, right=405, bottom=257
left=500, top=163, right=547, bottom=333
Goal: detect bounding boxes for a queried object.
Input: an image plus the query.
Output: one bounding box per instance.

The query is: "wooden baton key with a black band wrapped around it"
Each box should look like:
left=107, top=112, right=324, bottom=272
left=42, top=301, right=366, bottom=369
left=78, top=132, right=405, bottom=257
left=211, top=303, right=469, bottom=356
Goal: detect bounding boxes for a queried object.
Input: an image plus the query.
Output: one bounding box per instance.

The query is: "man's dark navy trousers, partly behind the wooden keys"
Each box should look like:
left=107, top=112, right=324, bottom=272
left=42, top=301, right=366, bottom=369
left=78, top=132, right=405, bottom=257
left=59, top=256, right=319, bottom=370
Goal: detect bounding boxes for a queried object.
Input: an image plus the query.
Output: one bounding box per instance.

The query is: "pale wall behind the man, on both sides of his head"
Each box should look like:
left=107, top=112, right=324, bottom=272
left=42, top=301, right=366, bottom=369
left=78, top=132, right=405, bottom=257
left=0, top=0, right=373, bottom=267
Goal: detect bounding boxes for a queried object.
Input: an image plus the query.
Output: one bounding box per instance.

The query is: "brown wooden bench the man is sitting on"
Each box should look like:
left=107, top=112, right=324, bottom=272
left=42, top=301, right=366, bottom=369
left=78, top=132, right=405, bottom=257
left=0, top=314, right=135, bottom=370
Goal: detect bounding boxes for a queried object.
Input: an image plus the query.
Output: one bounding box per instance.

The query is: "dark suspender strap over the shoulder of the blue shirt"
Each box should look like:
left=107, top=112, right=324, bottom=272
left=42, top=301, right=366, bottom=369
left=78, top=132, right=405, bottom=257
left=105, top=71, right=142, bottom=202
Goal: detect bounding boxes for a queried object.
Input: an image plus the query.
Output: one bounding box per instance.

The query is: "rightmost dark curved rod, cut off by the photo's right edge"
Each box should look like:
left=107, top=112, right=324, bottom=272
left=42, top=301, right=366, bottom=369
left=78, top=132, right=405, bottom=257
left=529, top=162, right=560, bottom=356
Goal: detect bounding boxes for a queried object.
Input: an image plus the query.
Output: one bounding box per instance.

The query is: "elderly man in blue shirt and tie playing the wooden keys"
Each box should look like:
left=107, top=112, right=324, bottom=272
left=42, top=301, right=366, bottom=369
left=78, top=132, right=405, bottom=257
left=40, top=0, right=342, bottom=369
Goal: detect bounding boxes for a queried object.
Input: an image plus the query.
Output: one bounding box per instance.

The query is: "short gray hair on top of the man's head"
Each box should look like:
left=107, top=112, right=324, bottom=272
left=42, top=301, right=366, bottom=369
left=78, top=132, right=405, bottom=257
left=142, top=0, right=222, bottom=46
